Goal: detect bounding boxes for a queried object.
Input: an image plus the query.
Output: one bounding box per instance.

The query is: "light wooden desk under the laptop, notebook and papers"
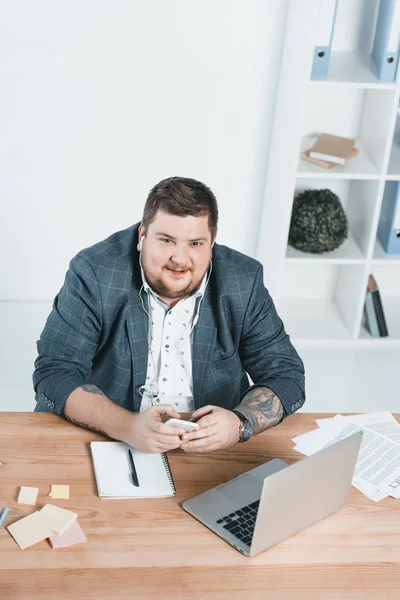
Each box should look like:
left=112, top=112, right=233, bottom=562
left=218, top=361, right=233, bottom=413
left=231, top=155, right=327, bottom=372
left=0, top=413, right=400, bottom=600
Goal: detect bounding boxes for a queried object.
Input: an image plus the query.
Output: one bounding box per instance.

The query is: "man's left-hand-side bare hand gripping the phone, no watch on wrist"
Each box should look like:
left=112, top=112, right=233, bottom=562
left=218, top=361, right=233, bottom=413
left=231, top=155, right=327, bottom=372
left=124, top=404, right=185, bottom=453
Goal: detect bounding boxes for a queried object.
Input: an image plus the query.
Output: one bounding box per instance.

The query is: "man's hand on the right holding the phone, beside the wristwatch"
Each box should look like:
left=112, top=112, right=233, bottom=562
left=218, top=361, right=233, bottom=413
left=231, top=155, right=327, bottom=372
left=181, top=405, right=240, bottom=452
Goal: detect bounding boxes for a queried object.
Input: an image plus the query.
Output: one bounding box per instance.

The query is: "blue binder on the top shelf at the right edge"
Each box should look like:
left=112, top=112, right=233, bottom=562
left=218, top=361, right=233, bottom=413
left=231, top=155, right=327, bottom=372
left=371, top=0, right=400, bottom=83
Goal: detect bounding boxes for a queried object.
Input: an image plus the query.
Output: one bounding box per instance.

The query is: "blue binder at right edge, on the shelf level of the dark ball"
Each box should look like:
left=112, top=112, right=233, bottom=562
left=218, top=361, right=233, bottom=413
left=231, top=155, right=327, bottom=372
left=378, top=181, right=400, bottom=254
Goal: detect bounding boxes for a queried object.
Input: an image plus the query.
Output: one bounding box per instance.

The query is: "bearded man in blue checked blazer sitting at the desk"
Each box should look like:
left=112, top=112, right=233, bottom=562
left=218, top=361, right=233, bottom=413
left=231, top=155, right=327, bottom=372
left=33, top=177, right=305, bottom=452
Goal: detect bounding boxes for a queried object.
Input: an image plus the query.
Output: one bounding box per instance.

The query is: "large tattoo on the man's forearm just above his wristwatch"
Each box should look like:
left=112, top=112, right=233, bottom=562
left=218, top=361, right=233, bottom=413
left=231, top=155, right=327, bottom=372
left=237, top=387, right=283, bottom=433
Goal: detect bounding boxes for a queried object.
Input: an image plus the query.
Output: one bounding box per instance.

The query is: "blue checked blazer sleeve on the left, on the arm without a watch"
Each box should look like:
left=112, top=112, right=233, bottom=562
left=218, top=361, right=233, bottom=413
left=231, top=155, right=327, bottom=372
left=33, top=254, right=102, bottom=415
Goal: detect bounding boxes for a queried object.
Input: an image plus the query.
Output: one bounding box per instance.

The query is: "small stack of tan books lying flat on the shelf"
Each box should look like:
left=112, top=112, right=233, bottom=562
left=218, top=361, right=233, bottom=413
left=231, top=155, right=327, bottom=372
left=301, top=133, right=358, bottom=169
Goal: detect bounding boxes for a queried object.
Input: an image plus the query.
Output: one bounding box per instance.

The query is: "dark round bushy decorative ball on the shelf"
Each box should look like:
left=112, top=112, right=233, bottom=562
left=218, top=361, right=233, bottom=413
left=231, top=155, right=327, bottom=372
left=289, top=190, right=348, bottom=254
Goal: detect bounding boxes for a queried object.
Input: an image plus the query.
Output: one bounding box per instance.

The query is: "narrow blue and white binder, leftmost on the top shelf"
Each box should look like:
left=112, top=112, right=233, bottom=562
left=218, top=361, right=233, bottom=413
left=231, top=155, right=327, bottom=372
left=311, top=0, right=337, bottom=79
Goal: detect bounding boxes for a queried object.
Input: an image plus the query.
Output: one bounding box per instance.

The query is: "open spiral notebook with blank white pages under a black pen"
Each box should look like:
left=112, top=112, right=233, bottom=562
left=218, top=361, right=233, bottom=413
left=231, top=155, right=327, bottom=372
left=90, top=442, right=175, bottom=499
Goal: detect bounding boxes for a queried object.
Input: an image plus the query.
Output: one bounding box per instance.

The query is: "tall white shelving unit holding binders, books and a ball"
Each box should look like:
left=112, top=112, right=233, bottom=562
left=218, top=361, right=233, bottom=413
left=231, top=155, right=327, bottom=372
left=257, top=0, right=400, bottom=410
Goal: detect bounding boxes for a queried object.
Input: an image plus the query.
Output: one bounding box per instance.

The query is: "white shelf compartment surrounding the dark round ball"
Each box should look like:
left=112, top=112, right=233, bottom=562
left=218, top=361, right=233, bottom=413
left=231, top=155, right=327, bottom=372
left=285, top=178, right=379, bottom=264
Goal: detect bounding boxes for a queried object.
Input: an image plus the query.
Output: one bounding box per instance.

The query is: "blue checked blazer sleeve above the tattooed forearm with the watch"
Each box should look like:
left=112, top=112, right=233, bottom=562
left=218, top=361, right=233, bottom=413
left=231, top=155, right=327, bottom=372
left=239, top=265, right=305, bottom=417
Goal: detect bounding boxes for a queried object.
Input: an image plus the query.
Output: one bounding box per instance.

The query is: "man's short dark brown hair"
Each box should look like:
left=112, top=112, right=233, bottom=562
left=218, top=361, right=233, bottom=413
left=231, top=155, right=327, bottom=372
left=142, top=177, right=218, bottom=239
